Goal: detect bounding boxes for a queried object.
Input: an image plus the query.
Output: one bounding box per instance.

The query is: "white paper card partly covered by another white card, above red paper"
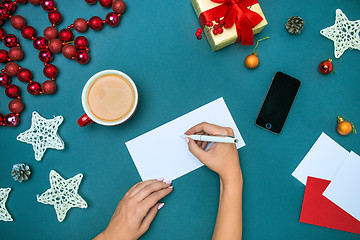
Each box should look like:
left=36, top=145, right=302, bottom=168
left=292, top=133, right=349, bottom=185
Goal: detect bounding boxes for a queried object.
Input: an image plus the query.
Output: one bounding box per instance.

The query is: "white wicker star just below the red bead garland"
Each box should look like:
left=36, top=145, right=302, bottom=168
left=16, top=112, right=64, bottom=161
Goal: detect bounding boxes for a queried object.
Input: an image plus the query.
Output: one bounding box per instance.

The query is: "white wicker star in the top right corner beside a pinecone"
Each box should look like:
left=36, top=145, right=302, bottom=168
left=320, top=9, right=360, bottom=58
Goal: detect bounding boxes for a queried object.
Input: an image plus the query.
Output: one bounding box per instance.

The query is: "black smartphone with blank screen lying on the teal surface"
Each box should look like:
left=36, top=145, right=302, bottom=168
left=255, top=72, right=300, bottom=134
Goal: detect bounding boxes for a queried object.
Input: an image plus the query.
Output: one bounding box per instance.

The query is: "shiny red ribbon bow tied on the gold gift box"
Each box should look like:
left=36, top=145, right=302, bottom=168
left=199, top=0, right=263, bottom=45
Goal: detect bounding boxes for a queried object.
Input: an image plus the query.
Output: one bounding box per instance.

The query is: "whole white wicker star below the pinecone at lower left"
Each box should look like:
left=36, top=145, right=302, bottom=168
left=37, top=170, right=87, bottom=222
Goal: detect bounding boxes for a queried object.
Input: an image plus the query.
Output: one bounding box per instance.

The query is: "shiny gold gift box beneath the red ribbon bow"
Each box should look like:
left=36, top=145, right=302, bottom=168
left=191, top=0, right=267, bottom=52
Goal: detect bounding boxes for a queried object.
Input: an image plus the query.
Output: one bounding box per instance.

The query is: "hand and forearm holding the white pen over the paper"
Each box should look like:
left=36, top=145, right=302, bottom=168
left=185, top=122, right=243, bottom=240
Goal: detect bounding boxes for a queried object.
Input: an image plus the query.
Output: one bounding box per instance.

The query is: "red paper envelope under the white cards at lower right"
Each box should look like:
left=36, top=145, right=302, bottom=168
left=300, top=177, right=360, bottom=234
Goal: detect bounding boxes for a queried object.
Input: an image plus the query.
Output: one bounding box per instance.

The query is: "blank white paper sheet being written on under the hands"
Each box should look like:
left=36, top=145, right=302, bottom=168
left=126, top=98, right=245, bottom=180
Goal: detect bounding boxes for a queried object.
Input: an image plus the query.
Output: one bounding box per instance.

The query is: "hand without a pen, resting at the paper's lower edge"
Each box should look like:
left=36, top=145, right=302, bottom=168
left=94, top=179, right=173, bottom=240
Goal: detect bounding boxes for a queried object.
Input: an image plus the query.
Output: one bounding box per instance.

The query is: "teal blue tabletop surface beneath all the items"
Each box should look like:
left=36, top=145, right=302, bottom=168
left=0, top=0, right=360, bottom=240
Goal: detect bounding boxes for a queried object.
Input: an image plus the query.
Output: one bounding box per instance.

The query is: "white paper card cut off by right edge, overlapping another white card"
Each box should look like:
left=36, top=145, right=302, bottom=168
left=323, top=152, right=360, bottom=221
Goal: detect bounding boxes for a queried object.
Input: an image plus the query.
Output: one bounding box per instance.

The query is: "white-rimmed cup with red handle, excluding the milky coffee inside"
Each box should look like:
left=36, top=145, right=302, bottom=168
left=77, top=70, right=139, bottom=127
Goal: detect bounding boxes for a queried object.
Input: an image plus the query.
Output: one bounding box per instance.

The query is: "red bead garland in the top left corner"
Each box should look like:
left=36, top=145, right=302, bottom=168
left=0, top=0, right=126, bottom=127
